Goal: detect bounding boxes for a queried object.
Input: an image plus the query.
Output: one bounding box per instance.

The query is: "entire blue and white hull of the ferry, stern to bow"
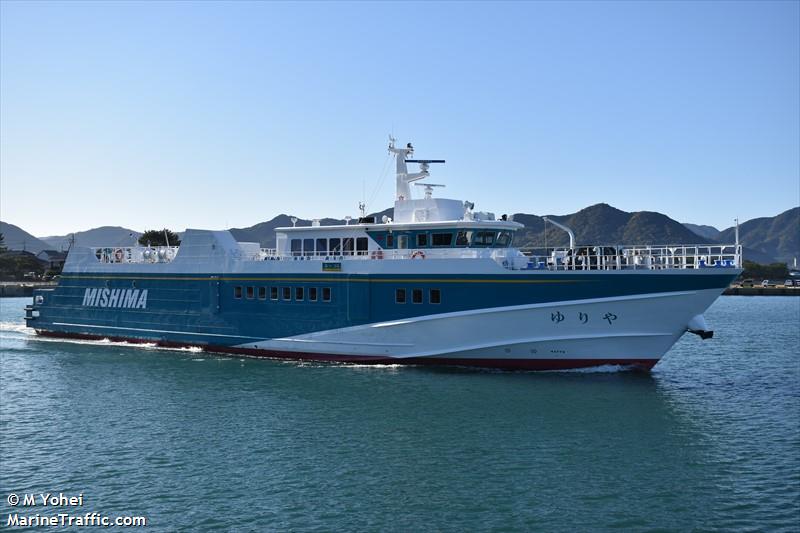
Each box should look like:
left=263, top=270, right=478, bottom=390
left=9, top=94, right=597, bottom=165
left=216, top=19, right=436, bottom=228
left=28, top=231, right=738, bottom=369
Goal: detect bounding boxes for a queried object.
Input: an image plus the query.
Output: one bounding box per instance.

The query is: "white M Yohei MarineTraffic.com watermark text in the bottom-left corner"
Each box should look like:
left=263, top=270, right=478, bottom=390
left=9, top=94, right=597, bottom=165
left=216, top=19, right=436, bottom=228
left=2, top=492, right=147, bottom=528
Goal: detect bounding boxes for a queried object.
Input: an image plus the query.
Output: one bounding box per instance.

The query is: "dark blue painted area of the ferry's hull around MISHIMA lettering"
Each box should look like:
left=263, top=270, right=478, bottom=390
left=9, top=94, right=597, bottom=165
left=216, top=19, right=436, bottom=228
left=28, top=270, right=738, bottom=346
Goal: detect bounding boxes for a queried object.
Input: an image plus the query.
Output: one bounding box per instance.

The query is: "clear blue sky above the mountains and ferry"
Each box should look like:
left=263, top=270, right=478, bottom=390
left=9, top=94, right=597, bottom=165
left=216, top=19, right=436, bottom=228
left=0, top=1, right=800, bottom=236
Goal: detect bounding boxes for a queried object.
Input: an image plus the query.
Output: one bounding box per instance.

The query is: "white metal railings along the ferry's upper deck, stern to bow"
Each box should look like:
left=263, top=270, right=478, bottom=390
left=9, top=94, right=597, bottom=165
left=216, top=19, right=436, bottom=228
left=86, top=244, right=742, bottom=271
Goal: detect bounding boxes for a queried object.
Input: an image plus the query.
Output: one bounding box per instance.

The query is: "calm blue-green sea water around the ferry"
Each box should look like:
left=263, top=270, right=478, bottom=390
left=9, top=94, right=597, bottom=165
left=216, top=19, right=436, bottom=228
left=0, top=297, right=800, bottom=531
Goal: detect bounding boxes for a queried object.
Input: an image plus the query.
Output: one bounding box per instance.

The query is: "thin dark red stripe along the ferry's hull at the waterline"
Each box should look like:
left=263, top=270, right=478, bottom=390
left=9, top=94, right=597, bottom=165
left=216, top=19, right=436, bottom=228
left=36, top=330, right=658, bottom=371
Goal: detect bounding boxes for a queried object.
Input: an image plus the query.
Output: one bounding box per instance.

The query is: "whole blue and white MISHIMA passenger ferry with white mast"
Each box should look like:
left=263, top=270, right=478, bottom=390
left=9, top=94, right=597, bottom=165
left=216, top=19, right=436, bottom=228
left=26, top=139, right=741, bottom=370
